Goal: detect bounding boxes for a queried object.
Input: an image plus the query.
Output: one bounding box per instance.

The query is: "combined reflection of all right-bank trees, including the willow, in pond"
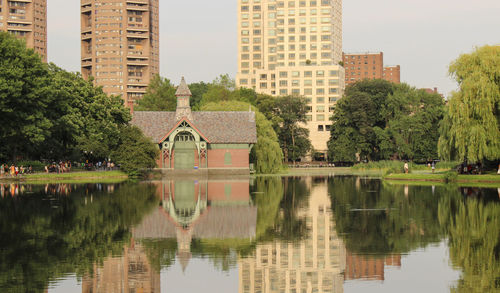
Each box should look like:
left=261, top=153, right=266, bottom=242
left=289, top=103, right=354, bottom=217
left=329, top=177, right=500, bottom=292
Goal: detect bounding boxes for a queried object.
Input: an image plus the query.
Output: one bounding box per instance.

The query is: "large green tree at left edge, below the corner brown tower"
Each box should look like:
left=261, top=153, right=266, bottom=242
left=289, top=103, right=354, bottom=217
left=0, top=32, right=52, bottom=161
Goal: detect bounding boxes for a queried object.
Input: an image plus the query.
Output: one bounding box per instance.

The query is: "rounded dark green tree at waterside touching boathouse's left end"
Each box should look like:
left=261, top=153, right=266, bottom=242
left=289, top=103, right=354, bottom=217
left=112, top=125, right=159, bottom=177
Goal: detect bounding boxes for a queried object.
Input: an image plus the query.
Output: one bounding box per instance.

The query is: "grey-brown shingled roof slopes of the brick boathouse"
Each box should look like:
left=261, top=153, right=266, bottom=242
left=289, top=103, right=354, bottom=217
left=131, top=111, right=257, bottom=144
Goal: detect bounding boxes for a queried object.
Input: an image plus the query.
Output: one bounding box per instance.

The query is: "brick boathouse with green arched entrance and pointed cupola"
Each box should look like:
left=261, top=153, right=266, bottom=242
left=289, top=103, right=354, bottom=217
left=131, top=78, right=257, bottom=174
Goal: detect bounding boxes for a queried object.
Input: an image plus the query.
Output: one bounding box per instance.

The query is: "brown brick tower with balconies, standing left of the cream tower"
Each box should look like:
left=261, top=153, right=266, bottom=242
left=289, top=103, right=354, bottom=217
left=81, top=0, right=160, bottom=103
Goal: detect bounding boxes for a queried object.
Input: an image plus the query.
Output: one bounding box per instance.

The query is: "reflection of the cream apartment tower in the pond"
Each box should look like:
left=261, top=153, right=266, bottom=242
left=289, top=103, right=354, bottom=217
left=239, top=178, right=346, bottom=293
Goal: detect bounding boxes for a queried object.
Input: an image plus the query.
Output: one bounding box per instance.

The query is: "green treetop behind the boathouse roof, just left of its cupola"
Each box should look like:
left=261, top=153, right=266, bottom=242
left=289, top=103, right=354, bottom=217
left=136, top=74, right=177, bottom=111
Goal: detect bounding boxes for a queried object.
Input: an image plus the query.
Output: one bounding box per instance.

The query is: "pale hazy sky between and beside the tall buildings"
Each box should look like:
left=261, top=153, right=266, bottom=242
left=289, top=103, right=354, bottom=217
left=48, top=0, right=500, bottom=94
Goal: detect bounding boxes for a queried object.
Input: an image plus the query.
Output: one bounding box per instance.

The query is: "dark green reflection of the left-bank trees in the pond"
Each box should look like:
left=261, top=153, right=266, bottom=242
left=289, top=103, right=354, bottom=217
left=0, top=184, right=156, bottom=292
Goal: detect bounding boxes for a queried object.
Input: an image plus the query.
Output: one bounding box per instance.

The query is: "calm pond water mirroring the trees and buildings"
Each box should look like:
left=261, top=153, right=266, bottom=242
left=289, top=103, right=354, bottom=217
left=0, top=176, right=500, bottom=293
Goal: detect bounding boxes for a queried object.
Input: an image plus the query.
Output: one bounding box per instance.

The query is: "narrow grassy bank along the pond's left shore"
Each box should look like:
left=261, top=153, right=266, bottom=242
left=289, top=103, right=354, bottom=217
left=0, top=171, right=128, bottom=183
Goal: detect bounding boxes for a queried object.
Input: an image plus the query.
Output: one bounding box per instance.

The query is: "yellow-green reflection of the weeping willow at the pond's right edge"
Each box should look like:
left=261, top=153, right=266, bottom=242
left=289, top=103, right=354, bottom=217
left=439, top=188, right=500, bottom=292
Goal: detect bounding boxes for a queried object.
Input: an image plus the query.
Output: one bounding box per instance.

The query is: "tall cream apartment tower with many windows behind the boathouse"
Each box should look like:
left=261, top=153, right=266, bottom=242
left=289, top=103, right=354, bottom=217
left=236, top=0, right=344, bottom=155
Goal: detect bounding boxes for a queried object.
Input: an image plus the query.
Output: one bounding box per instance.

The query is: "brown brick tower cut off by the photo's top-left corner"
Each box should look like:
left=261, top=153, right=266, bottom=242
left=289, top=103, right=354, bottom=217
left=0, top=0, right=47, bottom=62
